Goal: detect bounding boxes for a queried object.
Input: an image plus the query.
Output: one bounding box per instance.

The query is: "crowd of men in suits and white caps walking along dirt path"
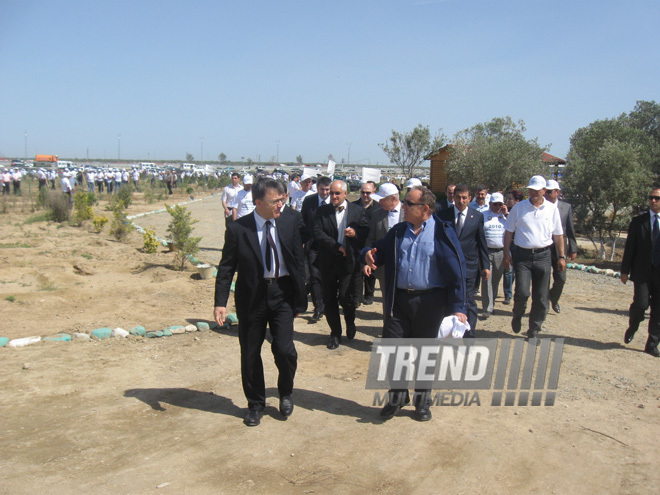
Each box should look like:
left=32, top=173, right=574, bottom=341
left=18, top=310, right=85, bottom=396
left=215, top=174, right=612, bottom=426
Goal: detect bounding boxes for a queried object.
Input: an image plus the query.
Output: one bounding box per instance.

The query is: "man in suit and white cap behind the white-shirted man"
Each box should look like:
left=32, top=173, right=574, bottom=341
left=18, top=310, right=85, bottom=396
left=545, top=179, right=577, bottom=313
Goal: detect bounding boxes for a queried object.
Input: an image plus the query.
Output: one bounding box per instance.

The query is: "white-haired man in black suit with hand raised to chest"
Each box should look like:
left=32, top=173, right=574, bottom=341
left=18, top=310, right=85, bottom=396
left=314, top=180, right=369, bottom=349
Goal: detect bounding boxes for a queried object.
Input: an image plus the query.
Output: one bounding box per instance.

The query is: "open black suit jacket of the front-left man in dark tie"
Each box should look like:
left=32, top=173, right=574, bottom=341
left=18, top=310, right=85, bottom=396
left=215, top=210, right=307, bottom=321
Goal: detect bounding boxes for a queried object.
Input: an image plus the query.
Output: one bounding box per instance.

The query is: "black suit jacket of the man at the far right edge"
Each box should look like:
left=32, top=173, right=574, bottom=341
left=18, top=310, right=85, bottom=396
left=621, top=211, right=653, bottom=283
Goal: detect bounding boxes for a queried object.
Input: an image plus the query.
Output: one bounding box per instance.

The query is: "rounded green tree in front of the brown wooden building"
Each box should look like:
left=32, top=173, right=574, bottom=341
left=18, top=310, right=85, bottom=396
left=447, top=116, right=549, bottom=191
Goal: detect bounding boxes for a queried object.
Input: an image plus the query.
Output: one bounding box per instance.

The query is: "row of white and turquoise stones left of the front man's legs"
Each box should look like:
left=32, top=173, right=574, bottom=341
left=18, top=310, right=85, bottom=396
left=0, top=313, right=238, bottom=347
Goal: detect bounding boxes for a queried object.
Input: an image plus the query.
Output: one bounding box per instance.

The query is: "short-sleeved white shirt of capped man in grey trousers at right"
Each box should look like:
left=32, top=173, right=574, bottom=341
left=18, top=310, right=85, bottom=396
left=504, top=198, right=564, bottom=249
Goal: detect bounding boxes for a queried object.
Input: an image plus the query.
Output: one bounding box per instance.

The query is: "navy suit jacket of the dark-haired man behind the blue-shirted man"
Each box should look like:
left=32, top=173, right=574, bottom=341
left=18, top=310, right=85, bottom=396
left=438, top=206, right=490, bottom=278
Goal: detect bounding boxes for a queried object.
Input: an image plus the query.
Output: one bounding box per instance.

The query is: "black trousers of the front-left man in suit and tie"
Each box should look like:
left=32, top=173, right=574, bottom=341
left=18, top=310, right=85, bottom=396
left=238, top=277, right=298, bottom=410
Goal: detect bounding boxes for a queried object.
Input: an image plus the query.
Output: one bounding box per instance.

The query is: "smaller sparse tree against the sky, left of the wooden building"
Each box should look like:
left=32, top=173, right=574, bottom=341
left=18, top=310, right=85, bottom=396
left=378, top=124, right=446, bottom=179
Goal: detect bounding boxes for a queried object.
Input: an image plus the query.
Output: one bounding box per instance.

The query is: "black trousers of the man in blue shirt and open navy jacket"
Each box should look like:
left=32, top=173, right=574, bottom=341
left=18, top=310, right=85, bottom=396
left=383, top=289, right=447, bottom=407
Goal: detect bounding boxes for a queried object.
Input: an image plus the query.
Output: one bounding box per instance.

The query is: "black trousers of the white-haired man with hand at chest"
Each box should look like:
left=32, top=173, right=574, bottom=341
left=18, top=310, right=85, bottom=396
left=321, top=254, right=360, bottom=337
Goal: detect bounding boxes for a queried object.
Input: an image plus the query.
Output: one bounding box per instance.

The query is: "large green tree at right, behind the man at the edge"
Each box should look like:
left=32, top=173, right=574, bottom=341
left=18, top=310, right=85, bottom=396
left=562, top=118, right=653, bottom=260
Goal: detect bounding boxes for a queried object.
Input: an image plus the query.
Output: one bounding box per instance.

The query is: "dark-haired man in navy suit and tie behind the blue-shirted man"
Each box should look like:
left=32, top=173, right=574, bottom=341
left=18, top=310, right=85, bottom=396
left=438, top=185, right=490, bottom=338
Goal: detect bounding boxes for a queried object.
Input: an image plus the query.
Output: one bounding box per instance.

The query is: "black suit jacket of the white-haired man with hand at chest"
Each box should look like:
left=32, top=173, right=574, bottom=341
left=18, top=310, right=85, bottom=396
left=314, top=202, right=369, bottom=273
